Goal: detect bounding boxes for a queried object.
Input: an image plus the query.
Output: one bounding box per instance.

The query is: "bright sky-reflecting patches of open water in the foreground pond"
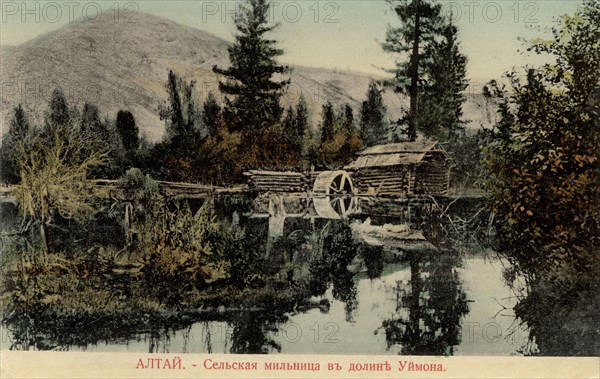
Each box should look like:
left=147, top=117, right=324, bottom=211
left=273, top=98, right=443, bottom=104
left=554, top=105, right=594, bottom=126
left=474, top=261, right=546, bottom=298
left=68, top=258, right=527, bottom=355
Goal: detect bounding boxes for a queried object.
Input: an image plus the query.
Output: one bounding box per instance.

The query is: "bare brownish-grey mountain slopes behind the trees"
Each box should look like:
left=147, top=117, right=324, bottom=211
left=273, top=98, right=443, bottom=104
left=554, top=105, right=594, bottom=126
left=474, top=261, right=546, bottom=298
left=0, top=13, right=490, bottom=140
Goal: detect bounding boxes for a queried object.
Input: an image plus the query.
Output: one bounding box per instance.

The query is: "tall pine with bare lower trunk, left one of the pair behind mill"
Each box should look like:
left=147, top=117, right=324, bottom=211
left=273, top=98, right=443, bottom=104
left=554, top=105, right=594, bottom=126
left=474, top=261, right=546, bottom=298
left=382, top=0, right=445, bottom=141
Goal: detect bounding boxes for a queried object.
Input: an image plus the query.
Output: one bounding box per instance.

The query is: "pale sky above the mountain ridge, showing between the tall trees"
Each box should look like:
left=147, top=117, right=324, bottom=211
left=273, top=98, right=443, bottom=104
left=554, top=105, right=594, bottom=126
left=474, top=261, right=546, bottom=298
left=0, top=0, right=581, bottom=87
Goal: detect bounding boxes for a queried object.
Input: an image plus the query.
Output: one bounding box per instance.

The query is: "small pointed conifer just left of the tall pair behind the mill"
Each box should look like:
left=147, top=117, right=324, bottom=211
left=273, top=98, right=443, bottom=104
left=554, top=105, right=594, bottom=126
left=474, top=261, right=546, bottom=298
left=360, top=81, right=389, bottom=147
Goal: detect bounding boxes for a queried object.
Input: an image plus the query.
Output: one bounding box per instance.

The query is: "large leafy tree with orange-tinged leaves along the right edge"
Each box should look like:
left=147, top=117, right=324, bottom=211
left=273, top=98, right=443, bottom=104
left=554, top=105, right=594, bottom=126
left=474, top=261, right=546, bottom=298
left=486, top=2, right=600, bottom=289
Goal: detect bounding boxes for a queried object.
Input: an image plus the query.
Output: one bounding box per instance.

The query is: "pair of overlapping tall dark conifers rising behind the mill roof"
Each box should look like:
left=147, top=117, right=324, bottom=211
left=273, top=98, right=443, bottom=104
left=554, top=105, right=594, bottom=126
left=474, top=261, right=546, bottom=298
left=382, top=0, right=468, bottom=141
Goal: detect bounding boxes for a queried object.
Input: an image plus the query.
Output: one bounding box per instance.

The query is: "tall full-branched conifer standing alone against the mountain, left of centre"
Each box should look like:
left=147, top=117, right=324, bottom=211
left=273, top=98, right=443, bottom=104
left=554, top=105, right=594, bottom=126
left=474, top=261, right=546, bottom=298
left=213, top=0, right=290, bottom=132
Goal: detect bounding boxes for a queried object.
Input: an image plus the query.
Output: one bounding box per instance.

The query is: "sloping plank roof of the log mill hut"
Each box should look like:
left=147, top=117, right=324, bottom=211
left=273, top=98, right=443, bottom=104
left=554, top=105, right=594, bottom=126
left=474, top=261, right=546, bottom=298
left=345, top=139, right=445, bottom=170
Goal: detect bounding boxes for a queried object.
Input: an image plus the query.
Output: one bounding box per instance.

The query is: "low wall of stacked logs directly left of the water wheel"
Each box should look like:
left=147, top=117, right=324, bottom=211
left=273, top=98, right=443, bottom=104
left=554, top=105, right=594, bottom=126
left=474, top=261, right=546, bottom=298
left=244, top=170, right=310, bottom=192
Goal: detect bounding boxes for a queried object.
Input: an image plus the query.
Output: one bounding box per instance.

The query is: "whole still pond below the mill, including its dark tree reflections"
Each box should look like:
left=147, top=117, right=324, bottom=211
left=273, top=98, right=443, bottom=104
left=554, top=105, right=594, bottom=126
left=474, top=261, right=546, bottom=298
left=0, top=199, right=528, bottom=355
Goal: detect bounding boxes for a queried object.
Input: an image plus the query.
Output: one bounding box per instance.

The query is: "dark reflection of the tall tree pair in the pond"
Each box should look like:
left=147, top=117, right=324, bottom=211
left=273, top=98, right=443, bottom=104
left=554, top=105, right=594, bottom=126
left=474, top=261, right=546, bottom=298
left=382, top=250, right=469, bottom=355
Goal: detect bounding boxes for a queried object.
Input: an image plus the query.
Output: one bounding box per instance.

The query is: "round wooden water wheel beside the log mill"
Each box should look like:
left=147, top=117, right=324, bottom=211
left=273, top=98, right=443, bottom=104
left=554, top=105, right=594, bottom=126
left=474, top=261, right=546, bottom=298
left=313, top=170, right=356, bottom=219
